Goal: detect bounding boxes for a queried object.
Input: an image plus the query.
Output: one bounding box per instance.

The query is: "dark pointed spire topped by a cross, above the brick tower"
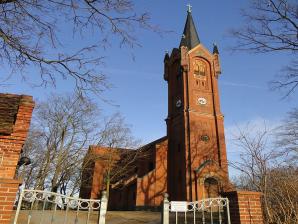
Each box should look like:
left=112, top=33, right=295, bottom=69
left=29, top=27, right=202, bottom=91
left=179, top=5, right=200, bottom=50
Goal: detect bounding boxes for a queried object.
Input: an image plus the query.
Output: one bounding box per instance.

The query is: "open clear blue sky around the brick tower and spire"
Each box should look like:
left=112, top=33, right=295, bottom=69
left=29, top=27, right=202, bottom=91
left=0, top=0, right=297, bottom=175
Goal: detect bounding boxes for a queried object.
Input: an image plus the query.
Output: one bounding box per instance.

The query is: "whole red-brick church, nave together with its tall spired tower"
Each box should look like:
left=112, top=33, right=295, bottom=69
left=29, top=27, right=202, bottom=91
left=80, top=8, right=232, bottom=209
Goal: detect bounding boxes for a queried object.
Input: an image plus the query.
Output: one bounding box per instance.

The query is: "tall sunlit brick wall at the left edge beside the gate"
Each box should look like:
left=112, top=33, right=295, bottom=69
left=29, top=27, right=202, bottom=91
left=0, top=94, right=34, bottom=224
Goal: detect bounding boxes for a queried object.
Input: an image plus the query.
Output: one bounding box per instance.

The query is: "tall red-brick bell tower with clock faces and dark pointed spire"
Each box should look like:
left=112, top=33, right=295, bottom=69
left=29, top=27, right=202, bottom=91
left=164, top=6, right=229, bottom=201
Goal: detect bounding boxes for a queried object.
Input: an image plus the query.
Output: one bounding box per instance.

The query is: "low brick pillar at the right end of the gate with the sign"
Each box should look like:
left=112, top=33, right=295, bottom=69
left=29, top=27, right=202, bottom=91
left=224, top=191, right=264, bottom=224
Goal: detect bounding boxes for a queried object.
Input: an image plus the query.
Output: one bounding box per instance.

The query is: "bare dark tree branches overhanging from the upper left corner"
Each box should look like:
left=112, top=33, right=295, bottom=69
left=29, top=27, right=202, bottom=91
left=0, top=0, right=158, bottom=93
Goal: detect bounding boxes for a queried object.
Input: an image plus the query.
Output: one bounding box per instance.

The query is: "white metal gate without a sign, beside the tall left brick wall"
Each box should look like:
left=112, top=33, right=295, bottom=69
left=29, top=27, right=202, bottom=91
left=13, top=189, right=107, bottom=224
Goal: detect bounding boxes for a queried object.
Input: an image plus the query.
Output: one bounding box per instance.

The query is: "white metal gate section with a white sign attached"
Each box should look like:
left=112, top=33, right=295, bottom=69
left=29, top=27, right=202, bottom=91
left=162, top=194, right=231, bottom=224
